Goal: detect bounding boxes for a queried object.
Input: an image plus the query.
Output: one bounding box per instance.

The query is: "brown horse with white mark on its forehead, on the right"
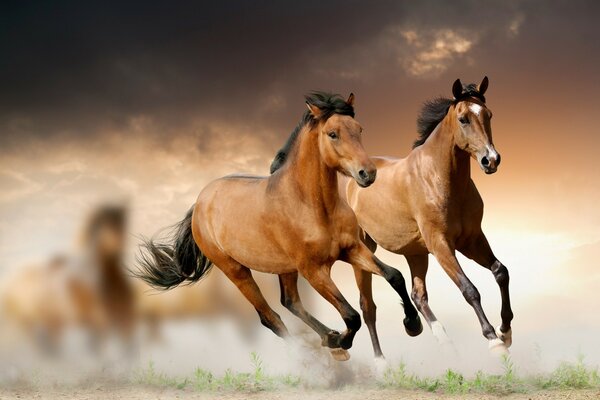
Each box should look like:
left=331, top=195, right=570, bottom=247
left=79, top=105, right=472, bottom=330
left=347, top=77, right=513, bottom=356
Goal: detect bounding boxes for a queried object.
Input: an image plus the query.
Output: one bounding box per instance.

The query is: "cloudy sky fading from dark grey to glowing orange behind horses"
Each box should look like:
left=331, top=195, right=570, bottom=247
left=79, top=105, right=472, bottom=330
left=0, top=0, right=600, bottom=372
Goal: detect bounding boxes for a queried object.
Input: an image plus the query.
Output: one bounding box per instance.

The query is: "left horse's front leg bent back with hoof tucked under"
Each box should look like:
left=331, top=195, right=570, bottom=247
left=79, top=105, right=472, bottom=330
left=299, top=265, right=361, bottom=360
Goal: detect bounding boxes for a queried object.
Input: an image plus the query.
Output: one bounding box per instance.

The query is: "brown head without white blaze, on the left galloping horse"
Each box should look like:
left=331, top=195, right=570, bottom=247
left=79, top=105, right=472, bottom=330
left=306, top=94, right=377, bottom=187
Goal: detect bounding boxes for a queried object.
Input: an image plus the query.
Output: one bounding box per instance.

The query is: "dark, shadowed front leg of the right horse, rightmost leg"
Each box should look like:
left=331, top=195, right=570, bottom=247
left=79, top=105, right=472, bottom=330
left=461, top=232, right=513, bottom=347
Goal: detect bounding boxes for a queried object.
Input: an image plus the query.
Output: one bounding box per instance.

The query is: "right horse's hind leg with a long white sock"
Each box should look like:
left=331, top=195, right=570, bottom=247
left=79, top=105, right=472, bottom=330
left=404, top=254, right=451, bottom=344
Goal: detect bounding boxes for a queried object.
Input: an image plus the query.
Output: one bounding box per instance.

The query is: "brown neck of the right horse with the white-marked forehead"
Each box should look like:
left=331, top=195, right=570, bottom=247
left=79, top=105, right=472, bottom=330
left=421, top=116, right=471, bottom=193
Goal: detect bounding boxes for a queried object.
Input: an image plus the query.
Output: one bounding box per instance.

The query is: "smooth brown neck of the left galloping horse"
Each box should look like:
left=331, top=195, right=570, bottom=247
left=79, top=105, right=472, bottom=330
left=287, top=128, right=339, bottom=214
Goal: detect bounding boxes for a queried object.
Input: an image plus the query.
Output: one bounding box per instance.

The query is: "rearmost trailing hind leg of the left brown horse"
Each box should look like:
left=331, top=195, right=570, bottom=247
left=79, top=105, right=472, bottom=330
left=215, top=258, right=289, bottom=338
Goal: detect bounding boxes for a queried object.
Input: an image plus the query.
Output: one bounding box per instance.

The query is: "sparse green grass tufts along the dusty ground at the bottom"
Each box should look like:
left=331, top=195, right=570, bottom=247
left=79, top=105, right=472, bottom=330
left=135, top=353, right=600, bottom=395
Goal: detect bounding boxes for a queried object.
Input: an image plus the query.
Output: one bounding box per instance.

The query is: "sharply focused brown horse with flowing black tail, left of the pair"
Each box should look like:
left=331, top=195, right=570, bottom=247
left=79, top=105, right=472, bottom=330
left=136, top=93, right=422, bottom=359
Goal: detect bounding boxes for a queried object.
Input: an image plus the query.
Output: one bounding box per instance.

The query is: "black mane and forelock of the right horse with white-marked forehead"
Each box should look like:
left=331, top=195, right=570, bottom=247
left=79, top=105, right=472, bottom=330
left=413, top=83, right=485, bottom=149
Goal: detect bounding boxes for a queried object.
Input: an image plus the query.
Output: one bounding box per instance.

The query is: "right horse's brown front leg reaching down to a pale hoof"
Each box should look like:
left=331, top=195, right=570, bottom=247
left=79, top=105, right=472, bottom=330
left=428, top=239, right=508, bottom=354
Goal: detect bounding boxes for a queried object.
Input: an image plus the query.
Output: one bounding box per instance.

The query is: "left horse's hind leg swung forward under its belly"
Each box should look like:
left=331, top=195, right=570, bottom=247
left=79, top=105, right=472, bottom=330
left=279, top=272, right=340, bottom=347
